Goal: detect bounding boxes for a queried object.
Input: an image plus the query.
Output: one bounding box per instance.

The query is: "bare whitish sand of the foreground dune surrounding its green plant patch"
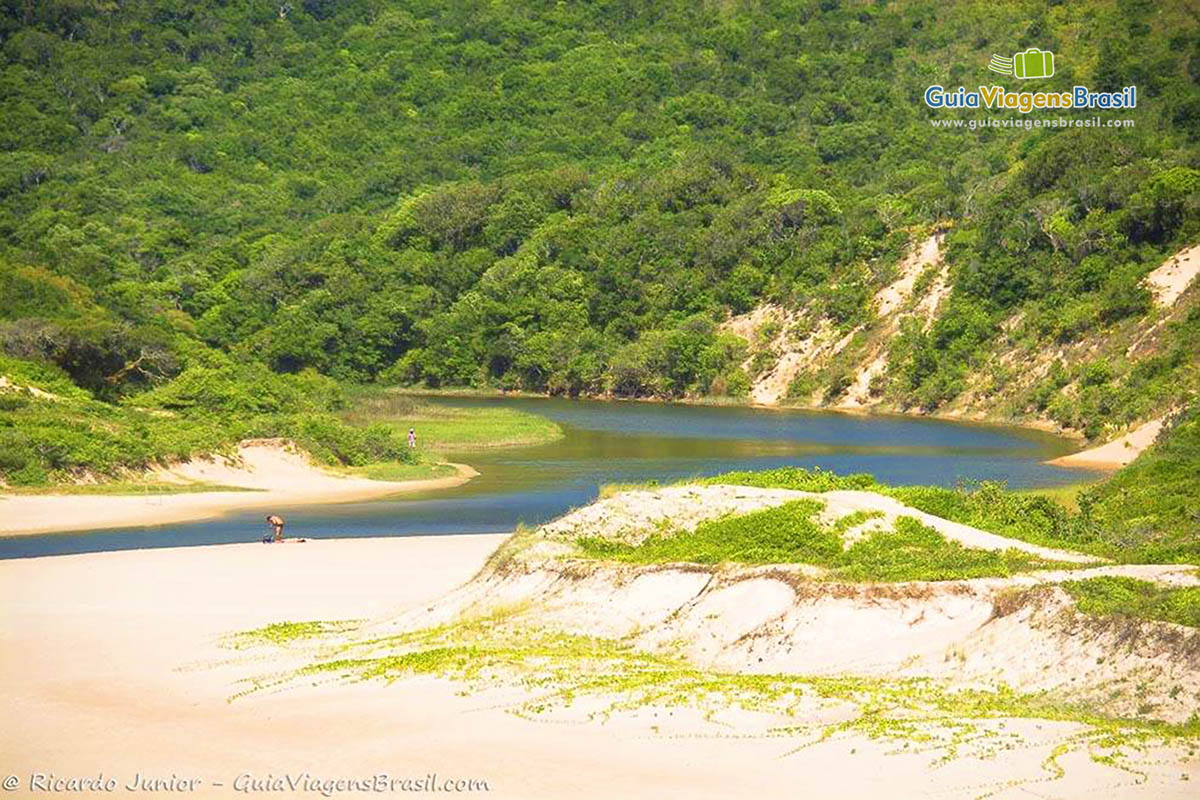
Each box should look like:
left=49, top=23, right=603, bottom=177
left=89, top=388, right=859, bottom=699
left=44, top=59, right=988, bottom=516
left=386, top=486, right=1200, bottom=723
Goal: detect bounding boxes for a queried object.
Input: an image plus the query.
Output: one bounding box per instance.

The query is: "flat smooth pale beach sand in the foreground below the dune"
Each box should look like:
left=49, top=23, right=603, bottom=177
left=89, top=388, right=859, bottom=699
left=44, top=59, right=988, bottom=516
left=0, top=535, right=1200, bottom=800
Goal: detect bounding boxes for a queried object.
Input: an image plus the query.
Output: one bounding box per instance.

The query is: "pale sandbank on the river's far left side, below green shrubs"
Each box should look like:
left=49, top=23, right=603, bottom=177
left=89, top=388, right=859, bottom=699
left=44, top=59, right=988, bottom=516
left=0, top=441, right=476, bottom=536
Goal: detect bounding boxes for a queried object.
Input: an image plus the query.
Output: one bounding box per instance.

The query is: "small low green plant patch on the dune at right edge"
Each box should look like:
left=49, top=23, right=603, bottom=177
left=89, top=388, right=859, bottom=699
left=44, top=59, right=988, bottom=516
left=1062, top=576, right=1200, bottom=627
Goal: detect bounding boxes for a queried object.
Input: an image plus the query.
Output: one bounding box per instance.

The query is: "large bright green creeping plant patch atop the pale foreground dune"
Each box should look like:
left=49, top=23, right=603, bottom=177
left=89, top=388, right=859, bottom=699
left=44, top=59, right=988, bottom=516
left=576, top=500, right=1072, bottom=582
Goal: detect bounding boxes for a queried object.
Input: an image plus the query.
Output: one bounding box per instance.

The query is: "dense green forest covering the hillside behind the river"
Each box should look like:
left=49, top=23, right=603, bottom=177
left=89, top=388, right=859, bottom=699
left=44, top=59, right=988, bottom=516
left=0, top=0, right=1200, bottom=489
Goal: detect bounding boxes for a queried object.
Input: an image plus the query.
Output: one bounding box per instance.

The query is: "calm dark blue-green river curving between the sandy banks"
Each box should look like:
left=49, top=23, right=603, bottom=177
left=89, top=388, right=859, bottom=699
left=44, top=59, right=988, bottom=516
left=0, top=398, right=1087, bottom=558
